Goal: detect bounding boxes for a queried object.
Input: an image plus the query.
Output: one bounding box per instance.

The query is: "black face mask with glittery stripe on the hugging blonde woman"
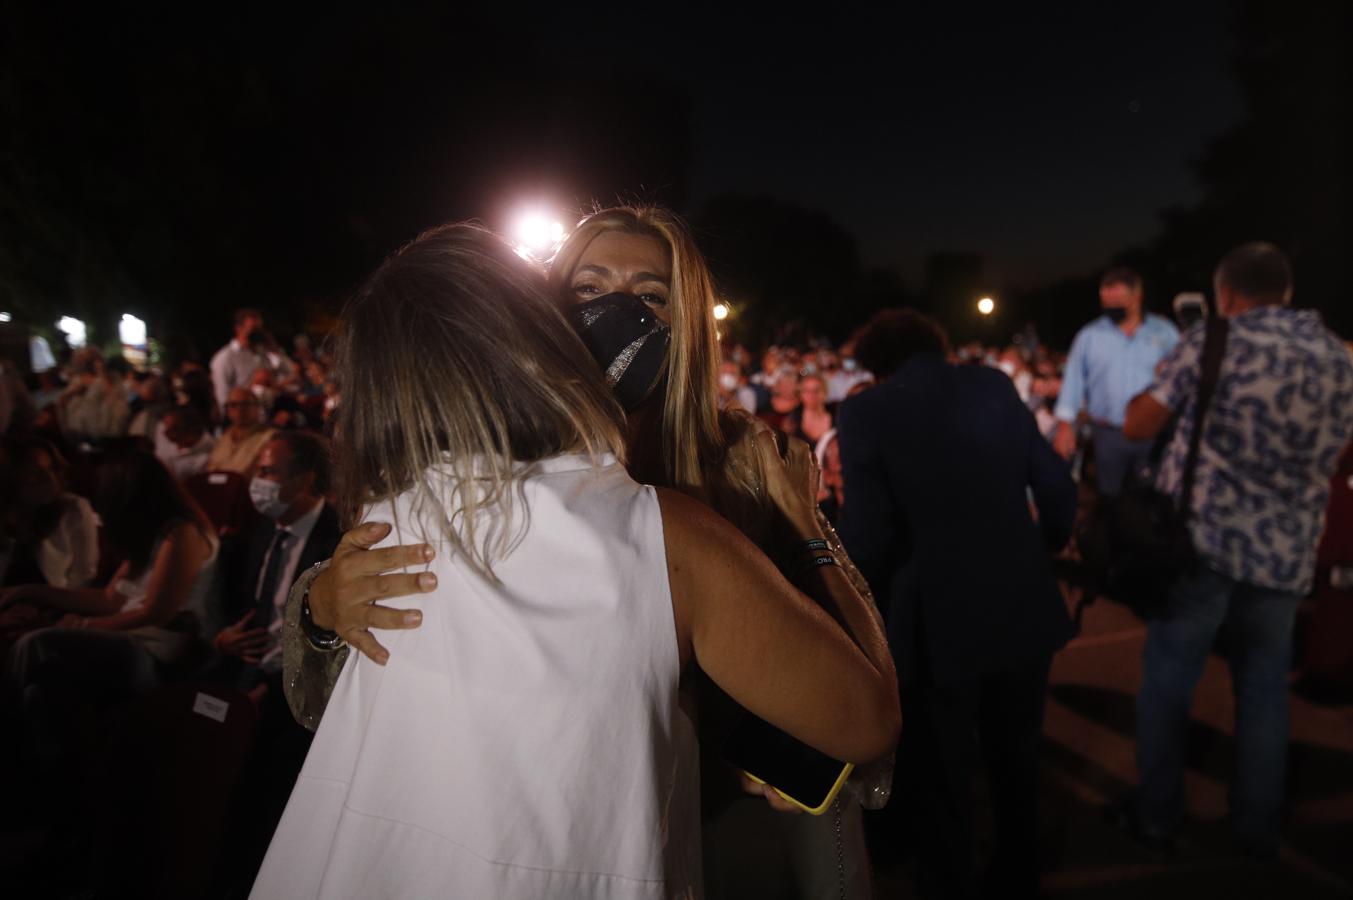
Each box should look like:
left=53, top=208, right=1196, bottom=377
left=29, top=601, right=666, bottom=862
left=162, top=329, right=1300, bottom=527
left=570, top=294, right=672, bottom=413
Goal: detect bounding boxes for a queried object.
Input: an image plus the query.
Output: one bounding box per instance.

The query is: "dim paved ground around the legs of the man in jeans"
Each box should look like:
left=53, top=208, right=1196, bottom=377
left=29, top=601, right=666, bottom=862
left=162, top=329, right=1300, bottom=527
left=874, top=600, right=1353, bottom=900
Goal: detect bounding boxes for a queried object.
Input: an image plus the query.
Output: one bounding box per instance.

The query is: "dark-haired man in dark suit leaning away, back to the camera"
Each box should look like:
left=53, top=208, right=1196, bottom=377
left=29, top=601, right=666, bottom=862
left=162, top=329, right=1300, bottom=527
left=838, top=310, right=1076, bottom=897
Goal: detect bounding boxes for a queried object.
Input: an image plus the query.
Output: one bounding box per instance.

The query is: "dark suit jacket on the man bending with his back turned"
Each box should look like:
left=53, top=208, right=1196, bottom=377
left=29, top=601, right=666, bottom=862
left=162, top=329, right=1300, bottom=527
left=838, top=355, right=1076, bottom=682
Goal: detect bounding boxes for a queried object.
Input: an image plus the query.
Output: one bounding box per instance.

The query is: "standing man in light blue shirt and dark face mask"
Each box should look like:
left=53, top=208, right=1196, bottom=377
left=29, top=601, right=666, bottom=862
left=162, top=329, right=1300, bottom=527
left=1054, top=268, right=1180, bottom=497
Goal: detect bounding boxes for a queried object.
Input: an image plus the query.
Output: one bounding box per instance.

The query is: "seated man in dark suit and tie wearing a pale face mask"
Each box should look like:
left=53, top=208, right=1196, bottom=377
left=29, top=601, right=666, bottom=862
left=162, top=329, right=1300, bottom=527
left=214, top=432, right=342, bottom=884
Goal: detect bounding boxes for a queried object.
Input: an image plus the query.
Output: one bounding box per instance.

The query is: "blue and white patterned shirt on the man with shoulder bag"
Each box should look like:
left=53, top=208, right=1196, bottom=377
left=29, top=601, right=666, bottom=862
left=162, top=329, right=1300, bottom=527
left=1150, top=306, right=1353, bottom=594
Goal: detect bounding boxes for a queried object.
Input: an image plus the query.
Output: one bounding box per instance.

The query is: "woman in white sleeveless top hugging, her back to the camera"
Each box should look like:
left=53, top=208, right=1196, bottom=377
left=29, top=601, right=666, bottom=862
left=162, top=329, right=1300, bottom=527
left=253, top=226, right=900, bottom=899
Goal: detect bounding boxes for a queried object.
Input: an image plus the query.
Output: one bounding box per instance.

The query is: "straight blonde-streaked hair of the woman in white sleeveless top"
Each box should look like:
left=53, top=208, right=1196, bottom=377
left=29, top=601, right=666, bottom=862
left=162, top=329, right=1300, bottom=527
left=336, top=225, right=625, bottom=579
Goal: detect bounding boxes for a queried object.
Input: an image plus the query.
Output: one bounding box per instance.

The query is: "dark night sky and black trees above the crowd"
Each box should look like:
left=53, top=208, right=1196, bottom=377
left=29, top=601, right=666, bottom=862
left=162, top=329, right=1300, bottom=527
left=0, top=1, right=1353, bottom=356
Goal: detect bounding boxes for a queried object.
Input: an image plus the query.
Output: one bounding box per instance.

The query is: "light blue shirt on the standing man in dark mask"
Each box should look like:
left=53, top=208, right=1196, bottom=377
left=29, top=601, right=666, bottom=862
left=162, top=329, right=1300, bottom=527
left=1055, top=313, right=1180, bottom=428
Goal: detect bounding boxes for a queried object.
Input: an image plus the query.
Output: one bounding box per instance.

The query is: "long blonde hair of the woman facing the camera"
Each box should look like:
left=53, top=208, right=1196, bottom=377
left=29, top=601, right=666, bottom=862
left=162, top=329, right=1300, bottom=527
left=549, top=206, right=767, bottom=540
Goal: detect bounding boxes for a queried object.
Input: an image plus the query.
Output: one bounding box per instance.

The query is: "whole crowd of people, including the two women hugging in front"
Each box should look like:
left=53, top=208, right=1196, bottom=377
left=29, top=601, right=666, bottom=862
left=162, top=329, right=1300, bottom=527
left=0, top=208, right=1353, bottom=897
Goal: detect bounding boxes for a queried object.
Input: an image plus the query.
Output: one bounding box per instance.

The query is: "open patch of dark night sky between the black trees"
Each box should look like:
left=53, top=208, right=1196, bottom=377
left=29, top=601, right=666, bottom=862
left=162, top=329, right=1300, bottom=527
left=681, top=3, right=1241, bottom=283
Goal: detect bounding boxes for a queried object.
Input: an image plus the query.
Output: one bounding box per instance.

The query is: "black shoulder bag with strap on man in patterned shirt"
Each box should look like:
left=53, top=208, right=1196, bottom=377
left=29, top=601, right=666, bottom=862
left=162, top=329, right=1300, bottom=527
left=1104, top=318, right=1229, bottom=618
